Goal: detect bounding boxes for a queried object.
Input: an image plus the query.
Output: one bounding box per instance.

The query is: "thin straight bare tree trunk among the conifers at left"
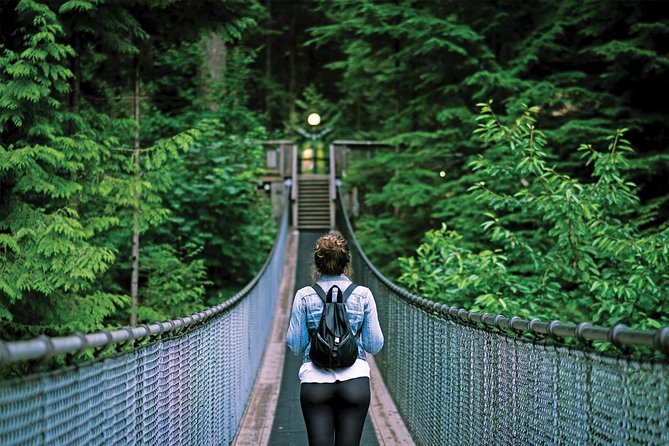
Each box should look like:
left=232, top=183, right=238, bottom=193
left=130, top=54, right=141, bottom=327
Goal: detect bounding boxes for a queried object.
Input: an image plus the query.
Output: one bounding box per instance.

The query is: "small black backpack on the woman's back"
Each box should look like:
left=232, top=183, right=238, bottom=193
left=309, top=283, right=358, bottom=369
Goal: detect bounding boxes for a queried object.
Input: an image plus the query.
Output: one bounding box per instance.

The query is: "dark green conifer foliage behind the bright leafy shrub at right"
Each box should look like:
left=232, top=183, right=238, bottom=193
left=308, top=0, right=669, bottom=286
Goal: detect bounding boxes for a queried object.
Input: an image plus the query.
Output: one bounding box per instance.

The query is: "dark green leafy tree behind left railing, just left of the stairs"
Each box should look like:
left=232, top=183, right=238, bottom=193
left=159, top=120, right=275, bottom=286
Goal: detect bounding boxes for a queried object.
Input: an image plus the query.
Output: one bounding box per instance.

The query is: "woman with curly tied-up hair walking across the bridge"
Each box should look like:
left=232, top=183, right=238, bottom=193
left=286, top=232, right=383, bottom=446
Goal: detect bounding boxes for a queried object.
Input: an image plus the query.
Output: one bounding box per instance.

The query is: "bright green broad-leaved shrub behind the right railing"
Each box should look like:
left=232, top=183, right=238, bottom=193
left=400, top=104, right=669, bottom=328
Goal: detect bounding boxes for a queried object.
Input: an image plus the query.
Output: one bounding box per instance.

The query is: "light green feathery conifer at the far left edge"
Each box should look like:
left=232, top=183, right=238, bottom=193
left=0, top=1, right=125, bottom=329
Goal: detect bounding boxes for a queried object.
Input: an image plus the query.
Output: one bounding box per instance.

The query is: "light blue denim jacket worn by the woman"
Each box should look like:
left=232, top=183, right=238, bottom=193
left=286, top=274, right=383, bottom=363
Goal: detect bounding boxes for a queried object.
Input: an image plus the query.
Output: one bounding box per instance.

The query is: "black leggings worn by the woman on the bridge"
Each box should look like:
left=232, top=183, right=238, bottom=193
left=300, top=377, right=370, bottom=446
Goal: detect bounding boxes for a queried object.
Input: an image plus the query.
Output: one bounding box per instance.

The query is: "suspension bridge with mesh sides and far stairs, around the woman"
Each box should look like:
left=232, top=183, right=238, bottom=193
left=0, top=141, right=669, bottom=445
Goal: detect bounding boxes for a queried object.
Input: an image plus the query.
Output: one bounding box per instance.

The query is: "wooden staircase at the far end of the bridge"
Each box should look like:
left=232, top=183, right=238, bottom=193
left=297, top=175, right=330, bottom=231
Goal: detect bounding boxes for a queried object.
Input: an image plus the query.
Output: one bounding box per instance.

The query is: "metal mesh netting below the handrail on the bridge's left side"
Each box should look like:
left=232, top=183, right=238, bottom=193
left=0, top=213, right=288, bottom=446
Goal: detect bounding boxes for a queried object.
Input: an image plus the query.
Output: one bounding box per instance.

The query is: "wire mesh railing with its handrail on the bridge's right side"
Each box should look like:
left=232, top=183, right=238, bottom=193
left=337, top=193, right=669, bottom=446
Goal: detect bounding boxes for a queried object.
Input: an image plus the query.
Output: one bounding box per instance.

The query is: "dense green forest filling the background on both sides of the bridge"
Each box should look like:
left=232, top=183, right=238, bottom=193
left=0, top=0, right=669, bottom=344
